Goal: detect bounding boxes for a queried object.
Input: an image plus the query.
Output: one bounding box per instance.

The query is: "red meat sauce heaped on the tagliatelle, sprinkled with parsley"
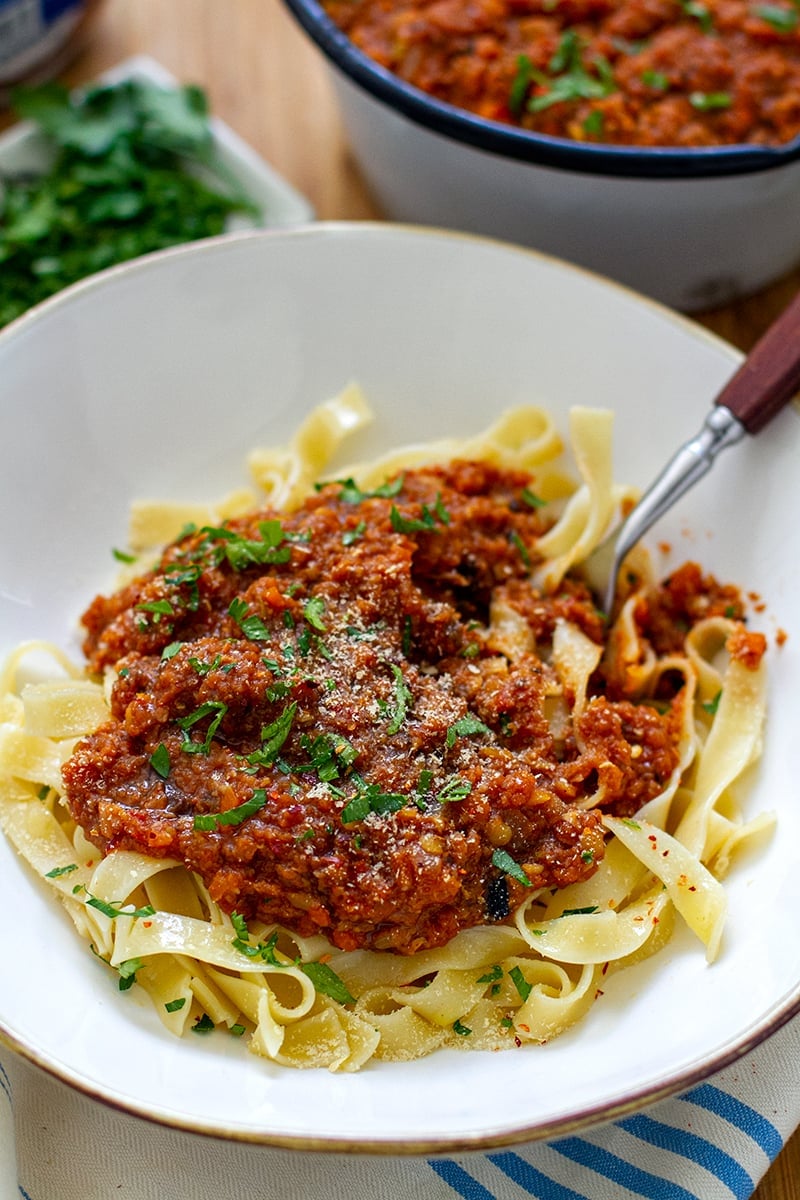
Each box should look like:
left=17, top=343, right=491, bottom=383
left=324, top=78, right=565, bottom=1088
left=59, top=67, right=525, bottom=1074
left=64, top=462, right=763, bottom=954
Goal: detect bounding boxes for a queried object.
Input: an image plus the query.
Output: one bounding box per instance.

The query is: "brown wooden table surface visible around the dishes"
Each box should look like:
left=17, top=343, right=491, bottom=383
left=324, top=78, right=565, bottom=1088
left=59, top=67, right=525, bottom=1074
left=0, top=0, right=800, bottom=1200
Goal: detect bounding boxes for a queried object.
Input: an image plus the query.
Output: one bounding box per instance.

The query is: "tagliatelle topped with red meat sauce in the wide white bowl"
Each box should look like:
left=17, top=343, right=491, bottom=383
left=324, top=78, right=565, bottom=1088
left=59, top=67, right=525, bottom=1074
left=0, top=386, right=769, bottom=1070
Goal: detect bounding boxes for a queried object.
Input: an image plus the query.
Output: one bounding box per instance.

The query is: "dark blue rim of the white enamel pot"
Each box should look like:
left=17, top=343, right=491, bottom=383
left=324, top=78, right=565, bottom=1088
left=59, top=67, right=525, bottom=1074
left=284, top=0, right=800, bottom=179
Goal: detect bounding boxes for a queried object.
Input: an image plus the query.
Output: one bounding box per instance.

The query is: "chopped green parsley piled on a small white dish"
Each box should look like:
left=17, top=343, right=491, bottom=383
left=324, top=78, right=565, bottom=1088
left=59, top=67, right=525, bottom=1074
left=0, top=79, right=259, bottom=325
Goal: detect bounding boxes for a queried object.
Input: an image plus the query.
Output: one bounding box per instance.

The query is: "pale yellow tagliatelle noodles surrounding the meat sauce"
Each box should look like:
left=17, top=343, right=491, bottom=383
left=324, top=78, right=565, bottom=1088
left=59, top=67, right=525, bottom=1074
left=0, top=385, right=769, bottom=1072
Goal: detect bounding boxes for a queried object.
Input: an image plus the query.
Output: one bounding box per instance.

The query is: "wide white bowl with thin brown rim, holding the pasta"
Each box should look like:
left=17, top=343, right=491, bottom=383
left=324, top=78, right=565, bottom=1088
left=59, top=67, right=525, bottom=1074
left=0, top=223, right=800, bottom=1152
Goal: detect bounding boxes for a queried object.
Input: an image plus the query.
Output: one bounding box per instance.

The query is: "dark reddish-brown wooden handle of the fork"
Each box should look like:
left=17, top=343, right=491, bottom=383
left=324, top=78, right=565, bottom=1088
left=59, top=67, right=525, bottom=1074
left=715, top=292, right=800, bottom=433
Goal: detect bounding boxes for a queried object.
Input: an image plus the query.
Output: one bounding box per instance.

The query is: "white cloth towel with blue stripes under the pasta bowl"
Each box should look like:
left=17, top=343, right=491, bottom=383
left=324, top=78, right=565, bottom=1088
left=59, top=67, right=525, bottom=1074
left=0, top=1016, right=800, bottom=1200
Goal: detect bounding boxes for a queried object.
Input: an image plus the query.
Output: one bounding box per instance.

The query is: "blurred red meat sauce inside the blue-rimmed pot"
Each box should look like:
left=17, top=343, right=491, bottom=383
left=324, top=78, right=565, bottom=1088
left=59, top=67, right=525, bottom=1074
left=325, top=0, right=800, bottom=148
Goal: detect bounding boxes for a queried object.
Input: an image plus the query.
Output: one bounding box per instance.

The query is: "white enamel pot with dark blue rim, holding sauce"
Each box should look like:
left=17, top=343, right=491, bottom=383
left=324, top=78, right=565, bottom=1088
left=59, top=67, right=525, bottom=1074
left=285, top=0, right=800, bottom=311
